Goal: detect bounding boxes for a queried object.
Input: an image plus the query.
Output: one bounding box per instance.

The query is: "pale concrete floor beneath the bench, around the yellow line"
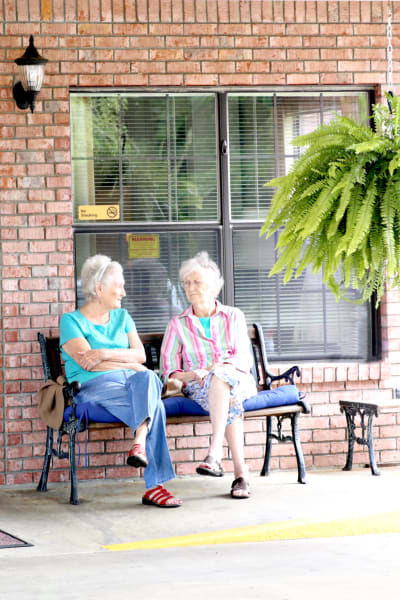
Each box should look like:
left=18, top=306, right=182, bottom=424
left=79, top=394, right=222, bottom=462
left=0, top=468, right=400, bottom=600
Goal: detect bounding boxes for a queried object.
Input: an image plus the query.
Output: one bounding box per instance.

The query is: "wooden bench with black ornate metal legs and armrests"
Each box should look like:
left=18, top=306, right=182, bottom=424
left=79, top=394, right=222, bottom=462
left=37, top=324, right=310, bottom=504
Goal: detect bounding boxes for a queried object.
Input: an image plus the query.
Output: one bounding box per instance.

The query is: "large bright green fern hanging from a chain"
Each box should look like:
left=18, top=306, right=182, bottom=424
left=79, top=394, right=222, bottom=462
left=260, top=97, right=400, bottom=304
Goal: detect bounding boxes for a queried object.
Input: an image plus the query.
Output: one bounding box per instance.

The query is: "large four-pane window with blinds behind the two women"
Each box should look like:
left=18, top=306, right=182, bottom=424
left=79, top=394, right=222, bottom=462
left=71, top=92, right=374, bottom=360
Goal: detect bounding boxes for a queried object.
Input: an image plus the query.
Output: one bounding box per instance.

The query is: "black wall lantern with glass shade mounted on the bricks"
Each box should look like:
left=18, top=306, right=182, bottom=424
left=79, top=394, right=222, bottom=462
left=13, top=35, right=47, bottom=112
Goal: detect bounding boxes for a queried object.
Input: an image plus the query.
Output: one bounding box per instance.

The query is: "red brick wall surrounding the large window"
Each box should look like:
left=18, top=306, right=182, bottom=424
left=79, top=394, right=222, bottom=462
left=0, top=0, right=400, bottom=484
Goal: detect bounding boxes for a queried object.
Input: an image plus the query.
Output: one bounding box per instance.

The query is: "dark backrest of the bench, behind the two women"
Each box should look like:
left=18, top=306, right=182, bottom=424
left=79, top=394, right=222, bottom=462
left=38, top=323, right=272, bottom=390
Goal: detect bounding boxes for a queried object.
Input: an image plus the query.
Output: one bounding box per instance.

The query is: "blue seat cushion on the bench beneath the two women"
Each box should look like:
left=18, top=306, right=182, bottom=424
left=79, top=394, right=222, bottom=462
left=64, top=385, right=301, bottom=423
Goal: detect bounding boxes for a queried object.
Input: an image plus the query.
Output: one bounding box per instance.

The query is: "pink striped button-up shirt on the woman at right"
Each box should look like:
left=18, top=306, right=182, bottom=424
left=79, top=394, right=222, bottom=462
left=161, top=301, right=253, bottom=380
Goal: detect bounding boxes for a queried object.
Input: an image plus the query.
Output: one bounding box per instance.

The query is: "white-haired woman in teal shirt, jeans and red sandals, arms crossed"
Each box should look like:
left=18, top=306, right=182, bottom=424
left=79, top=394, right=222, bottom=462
left=60, top=255, right=182, bottom=508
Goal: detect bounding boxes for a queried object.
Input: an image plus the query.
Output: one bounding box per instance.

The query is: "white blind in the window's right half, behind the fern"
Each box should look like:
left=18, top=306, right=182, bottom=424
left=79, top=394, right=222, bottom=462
left=228, top=92, right=371, bottom=360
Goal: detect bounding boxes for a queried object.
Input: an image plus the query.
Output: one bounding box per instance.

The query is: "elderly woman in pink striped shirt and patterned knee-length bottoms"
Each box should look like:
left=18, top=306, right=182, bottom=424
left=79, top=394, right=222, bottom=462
left=161, top=252, right=257, bottom=498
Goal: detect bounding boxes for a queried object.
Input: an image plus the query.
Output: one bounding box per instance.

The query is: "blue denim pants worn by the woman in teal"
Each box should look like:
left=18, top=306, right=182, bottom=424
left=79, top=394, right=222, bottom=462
left=75, top=370, right=175, bottom=488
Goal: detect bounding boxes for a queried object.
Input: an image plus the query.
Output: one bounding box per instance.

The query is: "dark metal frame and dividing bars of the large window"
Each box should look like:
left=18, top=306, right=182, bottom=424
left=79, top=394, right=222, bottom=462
left=70, top=86, right=382, bottom=362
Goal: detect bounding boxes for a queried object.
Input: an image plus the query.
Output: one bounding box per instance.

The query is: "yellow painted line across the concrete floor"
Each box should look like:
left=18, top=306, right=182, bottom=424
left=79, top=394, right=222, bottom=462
left=103, top=512, right=400, bottom=552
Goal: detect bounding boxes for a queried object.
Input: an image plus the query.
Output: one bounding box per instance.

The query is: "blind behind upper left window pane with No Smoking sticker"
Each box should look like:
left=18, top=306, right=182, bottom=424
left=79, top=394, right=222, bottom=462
left=71, top=94, right=219, bottom=223
